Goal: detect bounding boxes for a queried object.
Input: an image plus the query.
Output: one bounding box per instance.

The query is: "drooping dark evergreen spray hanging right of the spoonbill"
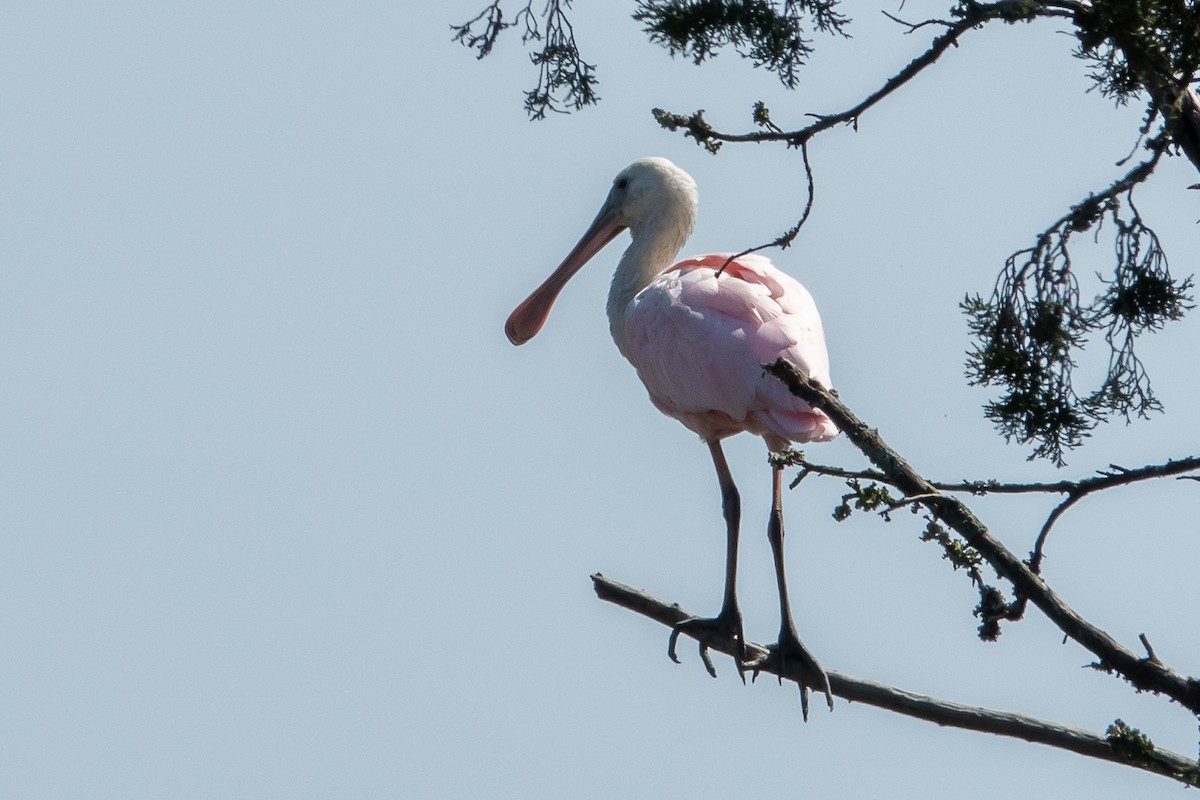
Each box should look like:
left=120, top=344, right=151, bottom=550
left=961, top=136, right=1192, bottom=465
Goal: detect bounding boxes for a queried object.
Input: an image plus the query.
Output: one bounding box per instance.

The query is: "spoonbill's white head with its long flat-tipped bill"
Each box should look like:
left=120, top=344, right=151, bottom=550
left=504, top=157, right=698, bottom=344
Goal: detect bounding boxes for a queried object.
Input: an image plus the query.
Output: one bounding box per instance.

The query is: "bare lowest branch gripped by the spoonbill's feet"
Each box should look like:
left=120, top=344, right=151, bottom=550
left=592, top=573, right=1200, bottom=787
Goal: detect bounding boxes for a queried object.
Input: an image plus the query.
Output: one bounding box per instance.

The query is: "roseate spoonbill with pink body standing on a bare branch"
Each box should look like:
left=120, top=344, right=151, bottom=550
left=504, top=158, right=838, bottom=718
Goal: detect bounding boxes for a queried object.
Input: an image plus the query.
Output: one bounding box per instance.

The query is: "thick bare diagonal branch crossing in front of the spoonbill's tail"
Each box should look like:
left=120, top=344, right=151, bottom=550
left=763, top=359, right=1200, bottom=714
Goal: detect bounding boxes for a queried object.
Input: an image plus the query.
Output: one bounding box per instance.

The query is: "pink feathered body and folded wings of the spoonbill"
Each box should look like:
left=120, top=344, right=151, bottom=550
left=623, top=253, right=838, bottom=450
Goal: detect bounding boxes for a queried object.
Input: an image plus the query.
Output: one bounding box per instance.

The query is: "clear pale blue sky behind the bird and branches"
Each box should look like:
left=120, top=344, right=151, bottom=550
left=0, top=0, right=1200, bottom=800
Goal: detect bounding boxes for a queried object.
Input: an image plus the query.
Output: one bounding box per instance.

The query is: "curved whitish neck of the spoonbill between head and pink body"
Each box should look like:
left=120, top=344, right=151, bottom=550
left=608, top=209, right=695, bottom=353
